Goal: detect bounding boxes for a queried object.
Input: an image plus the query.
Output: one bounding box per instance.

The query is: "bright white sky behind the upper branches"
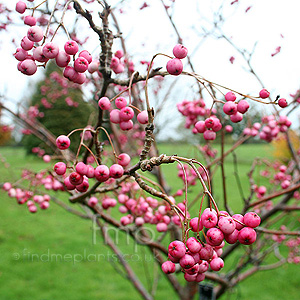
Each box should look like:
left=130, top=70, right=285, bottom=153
left=0, top=0, right=300, bottom=137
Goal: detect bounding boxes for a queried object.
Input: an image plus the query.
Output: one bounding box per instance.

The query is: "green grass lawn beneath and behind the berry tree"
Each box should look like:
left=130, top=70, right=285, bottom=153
left=0, top=144, right=300, bottom=300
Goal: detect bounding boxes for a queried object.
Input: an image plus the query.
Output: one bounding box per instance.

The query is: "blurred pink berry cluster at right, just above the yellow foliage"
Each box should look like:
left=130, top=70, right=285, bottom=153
left=243, top=115, right=292, bottom=142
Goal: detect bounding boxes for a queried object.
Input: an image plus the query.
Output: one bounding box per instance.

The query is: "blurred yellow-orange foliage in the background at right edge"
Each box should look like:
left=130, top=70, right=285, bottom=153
left=272, top=130, right=300, bottom=162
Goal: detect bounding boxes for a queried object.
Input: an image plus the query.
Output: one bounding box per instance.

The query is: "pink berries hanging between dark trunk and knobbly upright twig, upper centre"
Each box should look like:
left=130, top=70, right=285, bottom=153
left=98, top=97, right=148, bottom=130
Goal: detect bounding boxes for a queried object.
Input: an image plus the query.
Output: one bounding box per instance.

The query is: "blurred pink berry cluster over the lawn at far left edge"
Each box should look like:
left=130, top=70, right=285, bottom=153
left=3, top=182, right=51, bottom=213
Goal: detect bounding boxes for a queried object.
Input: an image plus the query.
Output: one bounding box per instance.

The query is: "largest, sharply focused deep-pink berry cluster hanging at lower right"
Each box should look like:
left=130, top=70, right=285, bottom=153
left=162, top=208, right=260, bottom=282
